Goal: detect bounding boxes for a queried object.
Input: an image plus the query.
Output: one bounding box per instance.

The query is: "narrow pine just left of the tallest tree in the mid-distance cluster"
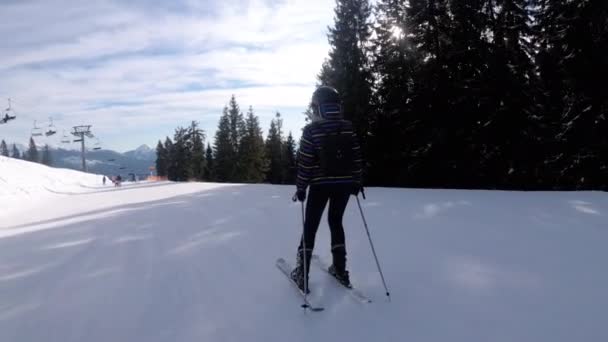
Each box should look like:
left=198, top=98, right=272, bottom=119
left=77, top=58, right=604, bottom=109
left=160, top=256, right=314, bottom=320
left=213, top=107, right=236, bottom=182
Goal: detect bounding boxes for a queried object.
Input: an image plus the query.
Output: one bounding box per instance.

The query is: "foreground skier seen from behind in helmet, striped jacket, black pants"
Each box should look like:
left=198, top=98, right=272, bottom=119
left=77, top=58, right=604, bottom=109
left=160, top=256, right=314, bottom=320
left=291, top=86, right=363, bottom=291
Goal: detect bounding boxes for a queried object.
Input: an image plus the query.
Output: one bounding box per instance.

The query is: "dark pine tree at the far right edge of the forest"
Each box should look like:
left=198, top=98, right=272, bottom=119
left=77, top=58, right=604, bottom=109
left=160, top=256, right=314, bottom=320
left=537, top=0, right=608, bottom=189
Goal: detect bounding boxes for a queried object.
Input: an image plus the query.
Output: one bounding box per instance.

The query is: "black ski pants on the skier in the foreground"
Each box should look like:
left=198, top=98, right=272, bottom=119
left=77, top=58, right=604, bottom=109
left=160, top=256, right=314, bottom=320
left=298, top=183, right=353, bottom=271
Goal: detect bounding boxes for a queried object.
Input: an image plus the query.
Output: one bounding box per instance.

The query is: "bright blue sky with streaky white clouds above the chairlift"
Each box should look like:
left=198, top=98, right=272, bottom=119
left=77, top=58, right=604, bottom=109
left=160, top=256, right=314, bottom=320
left=0, top=0, right=335, bottom=151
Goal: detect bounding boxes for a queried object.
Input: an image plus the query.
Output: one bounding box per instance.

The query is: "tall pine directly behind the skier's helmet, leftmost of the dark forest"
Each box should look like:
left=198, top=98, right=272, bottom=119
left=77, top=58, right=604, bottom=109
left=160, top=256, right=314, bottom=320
left=319, top=0, right=372, bottom=145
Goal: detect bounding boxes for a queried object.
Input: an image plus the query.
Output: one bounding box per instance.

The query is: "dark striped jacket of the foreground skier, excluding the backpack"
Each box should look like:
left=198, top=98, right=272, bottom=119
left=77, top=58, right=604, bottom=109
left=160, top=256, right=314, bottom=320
left=296, top=113, right=362, bottom=190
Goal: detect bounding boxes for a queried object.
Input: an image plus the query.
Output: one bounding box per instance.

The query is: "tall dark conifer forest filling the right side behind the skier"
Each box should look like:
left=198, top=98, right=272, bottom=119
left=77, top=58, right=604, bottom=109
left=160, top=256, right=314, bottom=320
left=319, top=0, right=608, bottom=190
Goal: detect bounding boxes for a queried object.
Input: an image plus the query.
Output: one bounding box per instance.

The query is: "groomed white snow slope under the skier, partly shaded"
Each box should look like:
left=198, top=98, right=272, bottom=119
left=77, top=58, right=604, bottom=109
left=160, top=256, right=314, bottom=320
left=0, top=158, right=608, bottom=342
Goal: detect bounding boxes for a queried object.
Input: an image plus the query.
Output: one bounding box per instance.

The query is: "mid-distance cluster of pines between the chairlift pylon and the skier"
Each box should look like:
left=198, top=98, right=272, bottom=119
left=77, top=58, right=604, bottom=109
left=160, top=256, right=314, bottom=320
left=156, top=96, right=296, bottom=184
